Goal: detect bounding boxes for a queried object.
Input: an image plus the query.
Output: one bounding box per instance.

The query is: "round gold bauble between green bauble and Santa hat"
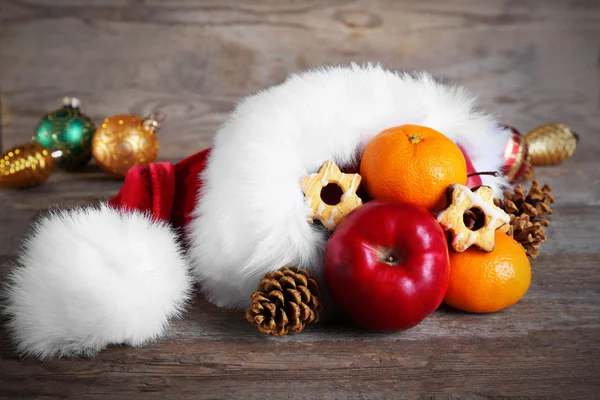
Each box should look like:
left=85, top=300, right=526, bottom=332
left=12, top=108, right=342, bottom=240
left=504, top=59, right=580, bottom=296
left=92, top=115, right=161, bottom=178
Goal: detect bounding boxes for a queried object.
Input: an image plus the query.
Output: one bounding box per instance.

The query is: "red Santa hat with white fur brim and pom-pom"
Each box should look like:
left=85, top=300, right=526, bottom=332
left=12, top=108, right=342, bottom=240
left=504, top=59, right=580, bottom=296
left=5, top=65, right=509, bottom=358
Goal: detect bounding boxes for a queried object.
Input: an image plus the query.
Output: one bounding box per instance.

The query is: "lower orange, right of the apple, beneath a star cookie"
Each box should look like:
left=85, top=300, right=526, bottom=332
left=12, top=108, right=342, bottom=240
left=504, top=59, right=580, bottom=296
left=444, top=231, right=531, bottom=313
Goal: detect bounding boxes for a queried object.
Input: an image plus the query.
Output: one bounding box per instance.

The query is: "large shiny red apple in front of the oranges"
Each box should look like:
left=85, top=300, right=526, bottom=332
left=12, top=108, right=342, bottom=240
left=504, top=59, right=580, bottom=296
left=325, top=200, right=449, bottom=332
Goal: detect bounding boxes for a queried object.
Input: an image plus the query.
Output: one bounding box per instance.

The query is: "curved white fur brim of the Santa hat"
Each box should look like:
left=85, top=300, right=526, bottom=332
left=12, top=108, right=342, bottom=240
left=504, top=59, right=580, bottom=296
left=188, top=65, right=508, bottom=307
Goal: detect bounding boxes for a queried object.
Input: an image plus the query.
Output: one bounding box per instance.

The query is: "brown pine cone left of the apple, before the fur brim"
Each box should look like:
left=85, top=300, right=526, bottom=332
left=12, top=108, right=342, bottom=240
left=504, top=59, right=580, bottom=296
left=246, top=267, right=322, bottom=336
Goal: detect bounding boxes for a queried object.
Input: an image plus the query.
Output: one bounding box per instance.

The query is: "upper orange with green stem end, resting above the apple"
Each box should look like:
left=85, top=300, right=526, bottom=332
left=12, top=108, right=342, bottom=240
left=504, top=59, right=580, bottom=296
left=360, top=125, right=467, bottom=211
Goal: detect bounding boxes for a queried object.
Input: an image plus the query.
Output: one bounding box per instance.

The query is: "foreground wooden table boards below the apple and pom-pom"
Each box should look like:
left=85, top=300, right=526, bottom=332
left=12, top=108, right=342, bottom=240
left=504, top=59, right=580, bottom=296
left=0, top=255, right=600, bottom=399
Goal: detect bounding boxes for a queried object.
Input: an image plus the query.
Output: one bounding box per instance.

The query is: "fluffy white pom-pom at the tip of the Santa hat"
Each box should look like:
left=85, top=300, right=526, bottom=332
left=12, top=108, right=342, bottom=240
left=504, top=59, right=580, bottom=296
left=4, top=205, right=191, bottom=359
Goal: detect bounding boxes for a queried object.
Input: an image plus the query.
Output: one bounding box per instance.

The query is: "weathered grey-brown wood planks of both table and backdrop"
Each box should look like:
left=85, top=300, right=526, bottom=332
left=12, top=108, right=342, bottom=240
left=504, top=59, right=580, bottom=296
left=0, top=0, right=600, bottom=399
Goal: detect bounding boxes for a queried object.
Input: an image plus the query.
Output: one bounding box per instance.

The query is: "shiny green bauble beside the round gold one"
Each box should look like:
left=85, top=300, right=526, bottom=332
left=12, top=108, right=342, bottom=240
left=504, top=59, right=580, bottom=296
left=33, top=97, right=96, bottom=170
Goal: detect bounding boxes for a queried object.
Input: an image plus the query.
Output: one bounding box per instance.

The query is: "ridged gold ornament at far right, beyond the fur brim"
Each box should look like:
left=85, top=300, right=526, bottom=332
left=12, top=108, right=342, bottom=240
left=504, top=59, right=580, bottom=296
left=525, top=124, right=579, bottom=165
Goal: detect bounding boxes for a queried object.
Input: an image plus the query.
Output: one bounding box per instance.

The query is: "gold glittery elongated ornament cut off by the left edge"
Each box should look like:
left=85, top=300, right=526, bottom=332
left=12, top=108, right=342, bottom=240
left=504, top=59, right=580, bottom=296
left=0, top=143, right=55, bottom=189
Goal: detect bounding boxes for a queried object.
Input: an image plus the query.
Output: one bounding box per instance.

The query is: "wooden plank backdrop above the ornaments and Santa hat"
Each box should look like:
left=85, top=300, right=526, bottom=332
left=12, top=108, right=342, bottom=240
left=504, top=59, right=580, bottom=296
left=0, top=0, right=600, bottom=159
